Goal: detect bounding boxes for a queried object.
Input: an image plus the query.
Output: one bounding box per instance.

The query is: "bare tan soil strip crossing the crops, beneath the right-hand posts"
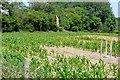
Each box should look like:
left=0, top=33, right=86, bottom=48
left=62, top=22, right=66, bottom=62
left=43, top=46, right=118, bottom=64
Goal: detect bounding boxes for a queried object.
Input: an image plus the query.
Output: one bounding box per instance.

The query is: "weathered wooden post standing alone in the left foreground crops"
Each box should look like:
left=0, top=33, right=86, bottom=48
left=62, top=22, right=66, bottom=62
left=24, top=58, right=30, bottom=79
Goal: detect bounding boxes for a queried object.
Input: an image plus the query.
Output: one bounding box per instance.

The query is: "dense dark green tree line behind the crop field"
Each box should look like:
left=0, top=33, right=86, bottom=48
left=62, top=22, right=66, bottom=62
left=1, top=2, right=117, bottom=32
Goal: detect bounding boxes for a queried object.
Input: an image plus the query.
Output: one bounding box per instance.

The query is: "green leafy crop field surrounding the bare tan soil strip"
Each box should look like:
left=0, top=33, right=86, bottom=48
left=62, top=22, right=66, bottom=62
left=2, top=32, right=119, bottom=78
